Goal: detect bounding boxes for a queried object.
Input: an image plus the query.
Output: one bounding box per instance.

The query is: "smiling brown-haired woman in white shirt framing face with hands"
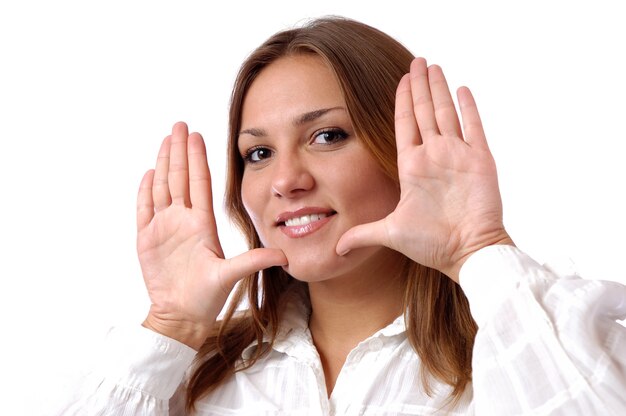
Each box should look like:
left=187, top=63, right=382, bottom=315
left=56, top=18, right=626, bottom=415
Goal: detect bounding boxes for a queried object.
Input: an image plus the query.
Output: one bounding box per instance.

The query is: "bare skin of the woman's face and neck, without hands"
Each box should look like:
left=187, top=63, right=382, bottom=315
left=238, top=55, right=404, bottom=394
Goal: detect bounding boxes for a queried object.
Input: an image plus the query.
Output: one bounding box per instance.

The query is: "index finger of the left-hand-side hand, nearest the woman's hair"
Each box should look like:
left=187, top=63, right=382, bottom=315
left=187, top=133, right=213, bottom=214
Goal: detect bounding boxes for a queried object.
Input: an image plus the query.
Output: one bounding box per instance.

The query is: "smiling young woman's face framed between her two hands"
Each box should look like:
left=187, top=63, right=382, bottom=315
left=238, top=55, right=400, bottom=281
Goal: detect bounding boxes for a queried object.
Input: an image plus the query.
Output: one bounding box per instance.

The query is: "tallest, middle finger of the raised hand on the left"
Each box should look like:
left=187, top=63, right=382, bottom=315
left=167, top=122, right=190, bottom=206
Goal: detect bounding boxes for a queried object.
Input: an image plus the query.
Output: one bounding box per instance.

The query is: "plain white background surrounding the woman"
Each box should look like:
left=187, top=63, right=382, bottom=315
left=0, top=0, right=626, bottom=415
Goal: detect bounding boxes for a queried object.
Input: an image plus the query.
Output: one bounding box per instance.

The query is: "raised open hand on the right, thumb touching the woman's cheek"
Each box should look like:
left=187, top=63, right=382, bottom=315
left=336, top=58, right=513, bottom=282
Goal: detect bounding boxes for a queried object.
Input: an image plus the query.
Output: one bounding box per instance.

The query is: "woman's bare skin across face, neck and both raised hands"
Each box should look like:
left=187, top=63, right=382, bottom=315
left=137, top=57, right=512, bottom=394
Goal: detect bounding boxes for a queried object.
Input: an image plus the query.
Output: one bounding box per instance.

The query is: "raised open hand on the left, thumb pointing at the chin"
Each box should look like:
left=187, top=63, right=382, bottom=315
left=137, top=122, right=287, bottom=350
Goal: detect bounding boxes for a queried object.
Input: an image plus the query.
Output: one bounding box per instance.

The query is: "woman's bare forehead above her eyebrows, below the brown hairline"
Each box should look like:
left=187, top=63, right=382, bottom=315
left=241, top=54, right=345, bottom=129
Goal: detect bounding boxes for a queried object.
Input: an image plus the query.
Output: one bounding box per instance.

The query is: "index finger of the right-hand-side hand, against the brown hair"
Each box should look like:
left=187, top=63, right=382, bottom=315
left=395, top=74, right=422, bottom=153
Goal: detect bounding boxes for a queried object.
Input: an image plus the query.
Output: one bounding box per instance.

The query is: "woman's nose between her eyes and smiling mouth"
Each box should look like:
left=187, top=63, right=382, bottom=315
left=272, top=152, right=315, bottom=198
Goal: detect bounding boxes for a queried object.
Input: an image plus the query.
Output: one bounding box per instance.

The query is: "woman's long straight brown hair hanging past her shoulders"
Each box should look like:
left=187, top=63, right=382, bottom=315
left=187, top=17, right=477, bottom=409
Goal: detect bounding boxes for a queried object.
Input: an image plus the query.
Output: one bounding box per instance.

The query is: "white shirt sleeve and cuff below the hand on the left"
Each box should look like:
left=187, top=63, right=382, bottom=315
left=52, top=325, right=196, bottom=416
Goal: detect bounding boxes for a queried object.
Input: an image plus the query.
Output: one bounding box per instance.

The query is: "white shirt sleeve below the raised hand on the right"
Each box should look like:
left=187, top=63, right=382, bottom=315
left=460, top=245, right=626, bottom=415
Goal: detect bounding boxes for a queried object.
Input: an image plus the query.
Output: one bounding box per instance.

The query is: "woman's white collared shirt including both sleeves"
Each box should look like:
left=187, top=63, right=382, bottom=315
left=48, top=246, right=626, bottom=416
